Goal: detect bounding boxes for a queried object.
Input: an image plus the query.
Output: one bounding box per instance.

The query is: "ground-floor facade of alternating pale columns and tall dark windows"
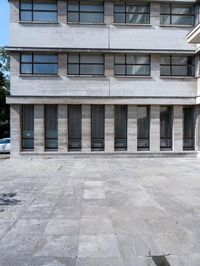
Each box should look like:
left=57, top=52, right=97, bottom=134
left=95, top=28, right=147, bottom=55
left=11, top=104, right=200, bottom=157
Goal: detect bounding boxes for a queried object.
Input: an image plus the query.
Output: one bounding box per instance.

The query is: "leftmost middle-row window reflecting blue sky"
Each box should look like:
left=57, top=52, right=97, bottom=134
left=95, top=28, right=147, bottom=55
left=20, top=53, right=58, bottom=75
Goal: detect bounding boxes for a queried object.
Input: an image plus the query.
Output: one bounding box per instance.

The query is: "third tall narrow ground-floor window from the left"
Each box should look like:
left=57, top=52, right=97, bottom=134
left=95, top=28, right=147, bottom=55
left=68, top=105, right=82, bottom=151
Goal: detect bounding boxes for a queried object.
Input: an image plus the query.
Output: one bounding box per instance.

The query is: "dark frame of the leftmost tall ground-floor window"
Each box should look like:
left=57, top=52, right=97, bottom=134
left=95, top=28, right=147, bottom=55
left=20, top=104, right=35, bottom=151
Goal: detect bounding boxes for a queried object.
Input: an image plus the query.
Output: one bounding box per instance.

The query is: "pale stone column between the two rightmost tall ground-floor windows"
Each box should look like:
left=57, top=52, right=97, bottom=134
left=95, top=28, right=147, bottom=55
left=173, top=105, right=183, bottom=152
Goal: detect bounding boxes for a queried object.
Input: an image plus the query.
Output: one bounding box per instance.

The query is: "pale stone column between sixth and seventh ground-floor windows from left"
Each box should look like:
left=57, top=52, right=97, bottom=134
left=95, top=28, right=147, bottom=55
left=150, top=105, right=160, bottom=152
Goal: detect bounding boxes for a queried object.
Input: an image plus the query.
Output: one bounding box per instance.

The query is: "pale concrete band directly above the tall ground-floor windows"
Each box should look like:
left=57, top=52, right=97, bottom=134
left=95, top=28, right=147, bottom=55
left=6, top=96, right=197, bottom=105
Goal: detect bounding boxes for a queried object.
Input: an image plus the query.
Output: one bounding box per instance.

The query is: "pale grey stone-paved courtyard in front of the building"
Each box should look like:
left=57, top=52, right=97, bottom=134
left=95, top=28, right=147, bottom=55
left=0, top=158, right=200, bottom=266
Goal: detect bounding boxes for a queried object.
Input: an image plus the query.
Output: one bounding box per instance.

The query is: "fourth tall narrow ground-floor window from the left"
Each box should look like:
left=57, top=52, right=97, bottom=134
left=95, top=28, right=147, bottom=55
left=91, top=105, right=105, bottom=151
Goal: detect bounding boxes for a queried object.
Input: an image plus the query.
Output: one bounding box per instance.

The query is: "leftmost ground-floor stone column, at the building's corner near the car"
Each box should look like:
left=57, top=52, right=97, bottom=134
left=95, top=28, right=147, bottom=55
left=10, top=105, right=21, bottom=158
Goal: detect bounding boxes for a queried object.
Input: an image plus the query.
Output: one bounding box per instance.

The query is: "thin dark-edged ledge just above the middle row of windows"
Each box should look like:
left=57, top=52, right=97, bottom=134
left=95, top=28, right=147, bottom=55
left=6, top=46, right=196, bottom=55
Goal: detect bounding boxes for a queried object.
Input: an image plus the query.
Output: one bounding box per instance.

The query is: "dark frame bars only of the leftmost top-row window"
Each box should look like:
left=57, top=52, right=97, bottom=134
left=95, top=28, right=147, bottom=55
left=19, top=0, right=58, bottom=23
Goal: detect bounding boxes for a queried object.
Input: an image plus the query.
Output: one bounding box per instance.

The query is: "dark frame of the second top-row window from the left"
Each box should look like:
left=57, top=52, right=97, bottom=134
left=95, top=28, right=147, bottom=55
left=67, top=0, right=105, bottom=24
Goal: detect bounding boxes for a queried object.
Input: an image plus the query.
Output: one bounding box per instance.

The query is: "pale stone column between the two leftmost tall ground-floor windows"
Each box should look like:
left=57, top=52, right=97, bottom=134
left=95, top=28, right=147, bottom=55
left=34, top=104, right=45, bottom=152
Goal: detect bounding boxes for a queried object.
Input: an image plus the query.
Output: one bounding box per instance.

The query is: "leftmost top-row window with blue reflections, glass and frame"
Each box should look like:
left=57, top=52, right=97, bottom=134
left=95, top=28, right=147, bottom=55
left=19, top=0, right=58, bottom=22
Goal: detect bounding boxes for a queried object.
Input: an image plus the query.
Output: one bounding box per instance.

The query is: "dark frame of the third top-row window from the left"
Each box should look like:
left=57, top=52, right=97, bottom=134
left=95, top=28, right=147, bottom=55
left=114, top=2, right=151, bottom=25
